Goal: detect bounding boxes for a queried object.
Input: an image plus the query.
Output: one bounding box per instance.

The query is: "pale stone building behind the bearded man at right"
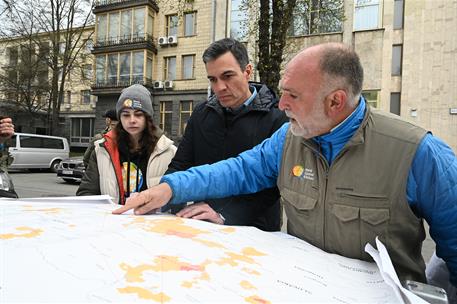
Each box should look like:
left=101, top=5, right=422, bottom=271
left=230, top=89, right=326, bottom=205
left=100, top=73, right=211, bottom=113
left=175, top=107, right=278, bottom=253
left=256, top=0, right=457, bottom=152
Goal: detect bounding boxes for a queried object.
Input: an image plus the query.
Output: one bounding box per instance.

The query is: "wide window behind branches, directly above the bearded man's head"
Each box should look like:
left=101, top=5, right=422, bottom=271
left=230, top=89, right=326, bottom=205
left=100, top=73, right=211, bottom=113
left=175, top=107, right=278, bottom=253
left=288, top=0, right=343, bottom=36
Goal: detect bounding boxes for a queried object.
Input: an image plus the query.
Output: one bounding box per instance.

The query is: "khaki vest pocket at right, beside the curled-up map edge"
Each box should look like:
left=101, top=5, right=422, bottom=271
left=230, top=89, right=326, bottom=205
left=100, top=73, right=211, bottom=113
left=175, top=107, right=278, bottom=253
left=325, top=204, right=390, bottom=260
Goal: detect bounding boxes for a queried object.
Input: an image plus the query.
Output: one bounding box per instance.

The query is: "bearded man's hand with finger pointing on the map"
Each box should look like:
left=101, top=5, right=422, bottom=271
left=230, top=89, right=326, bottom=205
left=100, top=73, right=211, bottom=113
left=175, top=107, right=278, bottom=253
left=112, top=183, right=173, bottom=215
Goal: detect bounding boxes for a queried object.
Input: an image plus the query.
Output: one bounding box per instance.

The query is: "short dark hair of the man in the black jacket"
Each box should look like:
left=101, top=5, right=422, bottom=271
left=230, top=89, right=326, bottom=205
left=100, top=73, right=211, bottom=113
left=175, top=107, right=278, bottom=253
left=202, top=38, right=249, bottom=71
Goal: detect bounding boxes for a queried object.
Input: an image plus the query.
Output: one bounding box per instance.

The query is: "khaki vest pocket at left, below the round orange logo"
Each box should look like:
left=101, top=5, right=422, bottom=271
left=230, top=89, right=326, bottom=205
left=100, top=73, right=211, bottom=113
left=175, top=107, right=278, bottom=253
left=281, top=188, right=323, bottom=246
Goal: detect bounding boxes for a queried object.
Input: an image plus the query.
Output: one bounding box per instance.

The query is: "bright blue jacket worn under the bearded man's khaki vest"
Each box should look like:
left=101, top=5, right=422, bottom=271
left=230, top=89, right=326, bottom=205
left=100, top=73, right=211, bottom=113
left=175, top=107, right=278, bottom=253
left=162, top=98, right=457, bottom=286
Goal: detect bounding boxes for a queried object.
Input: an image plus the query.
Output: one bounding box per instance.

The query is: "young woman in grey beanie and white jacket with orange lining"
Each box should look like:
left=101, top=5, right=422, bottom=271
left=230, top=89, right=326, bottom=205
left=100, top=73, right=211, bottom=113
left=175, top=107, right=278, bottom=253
left=76, top=84, right=176, bottom=205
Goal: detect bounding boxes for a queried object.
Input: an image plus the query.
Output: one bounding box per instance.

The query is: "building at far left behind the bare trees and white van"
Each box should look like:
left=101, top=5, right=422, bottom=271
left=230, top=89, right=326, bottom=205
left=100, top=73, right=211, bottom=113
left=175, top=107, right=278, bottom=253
left=0, top=26, right=96, bottom=147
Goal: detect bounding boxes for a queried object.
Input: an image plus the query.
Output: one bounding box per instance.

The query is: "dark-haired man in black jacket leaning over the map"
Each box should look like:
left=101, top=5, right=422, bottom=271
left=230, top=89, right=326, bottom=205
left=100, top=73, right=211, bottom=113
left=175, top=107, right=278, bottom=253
left=167, top=38, right=287, bottom=231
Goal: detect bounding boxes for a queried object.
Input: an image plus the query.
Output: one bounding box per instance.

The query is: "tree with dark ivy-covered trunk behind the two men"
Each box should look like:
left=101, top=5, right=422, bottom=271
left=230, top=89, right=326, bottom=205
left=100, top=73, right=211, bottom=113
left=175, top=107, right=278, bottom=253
left=241, top=0, right=344, bottom=92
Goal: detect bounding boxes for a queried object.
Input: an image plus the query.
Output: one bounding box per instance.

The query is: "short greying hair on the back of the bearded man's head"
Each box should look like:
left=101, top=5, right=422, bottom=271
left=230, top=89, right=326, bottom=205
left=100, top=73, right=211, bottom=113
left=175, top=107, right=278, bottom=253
left=319, top=44, right=363, bottom=97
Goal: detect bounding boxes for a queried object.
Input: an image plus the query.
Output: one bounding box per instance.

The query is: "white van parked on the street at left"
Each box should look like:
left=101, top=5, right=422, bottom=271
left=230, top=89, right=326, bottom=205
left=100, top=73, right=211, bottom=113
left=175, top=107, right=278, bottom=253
left=9, top=133, right=70, bottom=172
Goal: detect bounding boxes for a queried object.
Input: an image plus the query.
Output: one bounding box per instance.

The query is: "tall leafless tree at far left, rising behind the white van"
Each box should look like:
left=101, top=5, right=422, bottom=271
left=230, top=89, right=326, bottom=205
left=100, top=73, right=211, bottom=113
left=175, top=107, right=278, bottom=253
left=2, top=0, right=92, bottom=134
